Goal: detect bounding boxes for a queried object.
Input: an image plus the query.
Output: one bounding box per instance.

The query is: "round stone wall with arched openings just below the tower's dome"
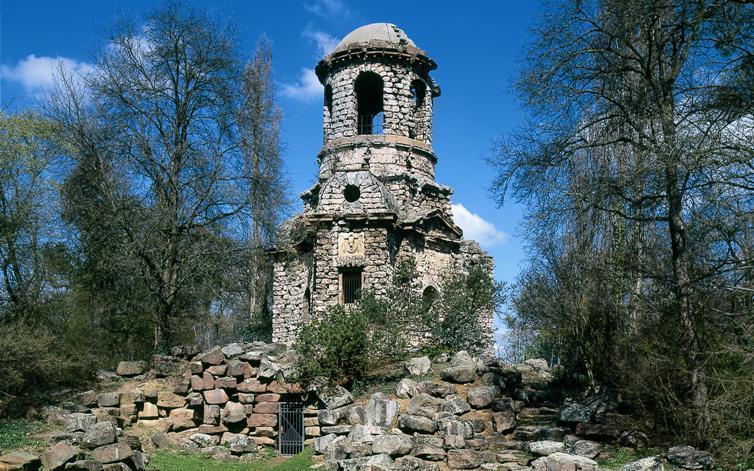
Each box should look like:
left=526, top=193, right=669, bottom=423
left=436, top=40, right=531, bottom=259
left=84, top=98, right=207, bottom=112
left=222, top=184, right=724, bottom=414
left=323, top=60, right=432, bottom=144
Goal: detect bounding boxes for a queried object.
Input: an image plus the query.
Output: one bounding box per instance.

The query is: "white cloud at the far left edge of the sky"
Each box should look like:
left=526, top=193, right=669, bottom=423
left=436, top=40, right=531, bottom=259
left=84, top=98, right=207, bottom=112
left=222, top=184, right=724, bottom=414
left=0, top=54, right=94, bottom=91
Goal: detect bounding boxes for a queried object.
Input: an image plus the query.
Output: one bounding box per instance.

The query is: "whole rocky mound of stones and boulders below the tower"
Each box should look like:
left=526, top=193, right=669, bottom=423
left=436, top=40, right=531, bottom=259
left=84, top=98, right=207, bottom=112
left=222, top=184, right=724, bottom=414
left=0, top=343, right=713, bottom=471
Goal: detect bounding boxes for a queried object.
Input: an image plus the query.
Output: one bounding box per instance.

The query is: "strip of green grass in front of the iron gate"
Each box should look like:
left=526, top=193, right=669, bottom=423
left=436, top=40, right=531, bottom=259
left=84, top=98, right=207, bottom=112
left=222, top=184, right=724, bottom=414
left=147, top=450, right=314, bottom=471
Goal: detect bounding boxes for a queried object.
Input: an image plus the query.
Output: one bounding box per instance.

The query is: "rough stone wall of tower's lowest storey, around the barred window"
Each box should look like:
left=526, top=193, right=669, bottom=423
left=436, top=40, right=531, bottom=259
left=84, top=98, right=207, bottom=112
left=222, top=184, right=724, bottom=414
left=273, top=225, right=493, bottom=346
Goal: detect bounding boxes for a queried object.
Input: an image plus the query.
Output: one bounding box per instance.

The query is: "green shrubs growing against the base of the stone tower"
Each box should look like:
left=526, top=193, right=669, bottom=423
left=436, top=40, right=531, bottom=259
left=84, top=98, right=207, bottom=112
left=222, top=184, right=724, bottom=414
left=296, top=259, right=502, bottom=386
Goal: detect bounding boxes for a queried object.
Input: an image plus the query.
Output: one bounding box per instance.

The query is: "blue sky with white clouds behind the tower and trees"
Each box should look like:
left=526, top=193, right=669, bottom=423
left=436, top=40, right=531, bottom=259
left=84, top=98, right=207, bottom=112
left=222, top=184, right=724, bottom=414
left=0, top=0, right=541, bottom=314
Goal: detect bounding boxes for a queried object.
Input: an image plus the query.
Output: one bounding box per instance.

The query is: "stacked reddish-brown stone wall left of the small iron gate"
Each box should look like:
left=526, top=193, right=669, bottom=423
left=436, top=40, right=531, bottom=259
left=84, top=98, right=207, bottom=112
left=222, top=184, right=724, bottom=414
left=73, top=343, right=302, bottom=455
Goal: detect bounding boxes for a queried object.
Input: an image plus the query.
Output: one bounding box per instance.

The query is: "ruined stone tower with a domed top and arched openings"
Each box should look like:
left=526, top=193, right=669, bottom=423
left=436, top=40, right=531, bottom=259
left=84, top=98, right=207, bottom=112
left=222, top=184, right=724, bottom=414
left=272, top=23, right=492, bottom=344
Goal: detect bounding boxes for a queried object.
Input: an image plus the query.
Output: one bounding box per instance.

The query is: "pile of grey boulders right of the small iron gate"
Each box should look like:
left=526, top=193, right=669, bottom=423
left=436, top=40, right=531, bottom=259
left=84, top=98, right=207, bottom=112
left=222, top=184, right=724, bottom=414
left=312, top=352, right=696, bottom=471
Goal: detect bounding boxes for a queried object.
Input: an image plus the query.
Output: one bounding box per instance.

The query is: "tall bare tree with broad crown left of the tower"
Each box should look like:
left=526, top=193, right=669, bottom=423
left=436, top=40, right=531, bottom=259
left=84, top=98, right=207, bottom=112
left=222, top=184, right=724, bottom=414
left=49, top=3, right=249, bottom=350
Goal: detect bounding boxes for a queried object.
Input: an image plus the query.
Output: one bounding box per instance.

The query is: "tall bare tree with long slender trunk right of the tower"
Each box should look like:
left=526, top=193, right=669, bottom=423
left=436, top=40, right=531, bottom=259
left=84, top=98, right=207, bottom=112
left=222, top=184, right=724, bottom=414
left=495, top=0, right=751, bottom=441
